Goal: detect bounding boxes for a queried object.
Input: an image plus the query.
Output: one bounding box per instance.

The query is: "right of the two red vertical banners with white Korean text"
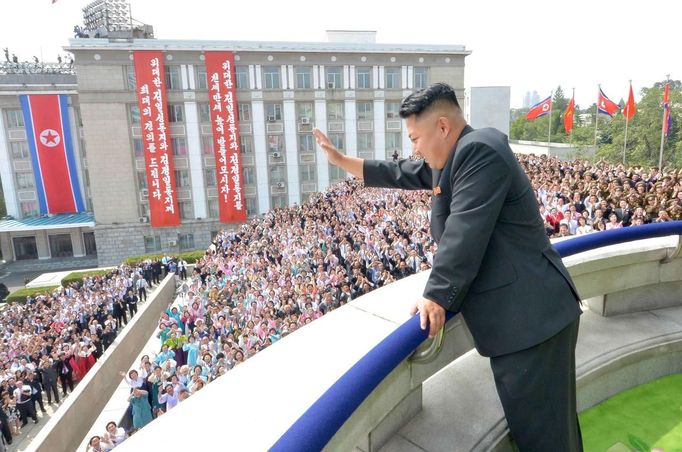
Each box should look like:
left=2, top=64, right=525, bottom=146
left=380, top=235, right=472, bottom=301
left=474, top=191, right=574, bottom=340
left=205, top=52, right=246, bottom=223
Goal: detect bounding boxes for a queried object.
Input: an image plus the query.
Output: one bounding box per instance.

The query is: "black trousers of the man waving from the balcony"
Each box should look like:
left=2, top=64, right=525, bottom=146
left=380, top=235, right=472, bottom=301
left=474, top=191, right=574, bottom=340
left=490, top=319, right=583, bottom=452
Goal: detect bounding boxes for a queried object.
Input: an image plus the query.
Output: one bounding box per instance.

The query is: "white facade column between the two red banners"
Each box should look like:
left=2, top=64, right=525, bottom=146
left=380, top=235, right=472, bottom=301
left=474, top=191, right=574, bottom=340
left=185, top=102, right=208, bottom=218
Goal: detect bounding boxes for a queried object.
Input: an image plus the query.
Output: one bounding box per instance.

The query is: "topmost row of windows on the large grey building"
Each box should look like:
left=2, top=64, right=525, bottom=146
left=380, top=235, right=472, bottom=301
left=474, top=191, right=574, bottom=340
left=126, top=65, right=427, bottom=91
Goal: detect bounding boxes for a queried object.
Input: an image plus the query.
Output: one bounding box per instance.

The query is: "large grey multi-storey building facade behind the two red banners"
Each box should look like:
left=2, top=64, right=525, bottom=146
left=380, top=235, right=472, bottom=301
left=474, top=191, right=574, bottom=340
left=0, top=32, right=470, bottom=264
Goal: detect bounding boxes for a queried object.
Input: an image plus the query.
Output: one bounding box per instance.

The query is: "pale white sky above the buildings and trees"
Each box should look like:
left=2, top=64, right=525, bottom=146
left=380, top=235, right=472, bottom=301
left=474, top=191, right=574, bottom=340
left=0, top=0, right=682, bottom=108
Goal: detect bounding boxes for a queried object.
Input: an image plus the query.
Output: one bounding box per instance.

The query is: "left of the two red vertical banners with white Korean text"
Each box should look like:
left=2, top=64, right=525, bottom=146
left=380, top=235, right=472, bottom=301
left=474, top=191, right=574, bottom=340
left=133, top=50, right=180, bottom=228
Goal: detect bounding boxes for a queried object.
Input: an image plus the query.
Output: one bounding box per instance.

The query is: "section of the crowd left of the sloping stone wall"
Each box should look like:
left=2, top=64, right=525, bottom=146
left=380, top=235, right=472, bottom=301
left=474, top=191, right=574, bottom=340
left=0, top=261, right=167, bottom=444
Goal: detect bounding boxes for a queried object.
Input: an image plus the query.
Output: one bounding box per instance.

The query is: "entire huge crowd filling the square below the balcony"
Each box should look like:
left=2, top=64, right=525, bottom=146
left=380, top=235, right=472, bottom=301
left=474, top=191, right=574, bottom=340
left=0, top=155, right=682, bottom=450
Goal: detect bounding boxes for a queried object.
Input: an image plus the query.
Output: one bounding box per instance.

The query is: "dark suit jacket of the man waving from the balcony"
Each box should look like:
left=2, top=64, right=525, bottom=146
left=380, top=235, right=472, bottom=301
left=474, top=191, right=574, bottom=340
left=363, top=126, right=581, bottom=356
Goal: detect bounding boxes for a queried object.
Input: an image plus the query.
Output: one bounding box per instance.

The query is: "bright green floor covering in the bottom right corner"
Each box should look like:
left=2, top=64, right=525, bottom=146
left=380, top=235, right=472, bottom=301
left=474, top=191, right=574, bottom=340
left=579, top=374, right=682, bottom=452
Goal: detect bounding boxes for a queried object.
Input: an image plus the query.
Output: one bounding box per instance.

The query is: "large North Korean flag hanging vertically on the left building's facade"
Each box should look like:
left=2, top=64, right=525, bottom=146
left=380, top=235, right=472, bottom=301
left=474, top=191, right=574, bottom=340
left=19, top=94, right=85, bottom=215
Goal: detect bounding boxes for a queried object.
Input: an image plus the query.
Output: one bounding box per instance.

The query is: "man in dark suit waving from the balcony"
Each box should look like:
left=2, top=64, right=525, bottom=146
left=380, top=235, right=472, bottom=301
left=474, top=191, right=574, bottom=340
left=314, top=83, right=582, bottom=452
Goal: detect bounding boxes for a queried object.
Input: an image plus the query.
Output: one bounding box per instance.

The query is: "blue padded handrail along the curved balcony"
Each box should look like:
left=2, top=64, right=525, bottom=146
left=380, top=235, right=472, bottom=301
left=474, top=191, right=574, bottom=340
left=270, top=221, right=682, bottom=452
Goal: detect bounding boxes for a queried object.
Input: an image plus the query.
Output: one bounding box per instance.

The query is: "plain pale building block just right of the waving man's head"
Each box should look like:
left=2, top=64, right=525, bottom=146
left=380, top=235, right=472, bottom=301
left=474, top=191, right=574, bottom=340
left=464, top=86, right=510, bottom=135
